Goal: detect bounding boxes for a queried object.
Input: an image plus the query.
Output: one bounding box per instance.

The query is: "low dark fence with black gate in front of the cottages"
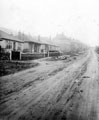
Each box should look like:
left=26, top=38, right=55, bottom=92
left=0, top=47, right=60, bottom=60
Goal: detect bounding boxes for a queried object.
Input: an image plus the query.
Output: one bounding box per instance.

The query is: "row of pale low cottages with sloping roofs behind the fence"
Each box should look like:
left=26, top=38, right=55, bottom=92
left=0, top=30, right=59, bottom=59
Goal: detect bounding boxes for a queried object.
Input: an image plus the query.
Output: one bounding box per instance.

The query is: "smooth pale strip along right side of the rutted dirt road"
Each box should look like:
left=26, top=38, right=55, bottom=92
left=74, top=50, right=99, bottom=120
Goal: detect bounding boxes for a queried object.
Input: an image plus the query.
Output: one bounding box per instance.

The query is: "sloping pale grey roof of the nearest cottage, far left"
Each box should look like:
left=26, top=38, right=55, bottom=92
left=0, top=30, right=23, bottom=42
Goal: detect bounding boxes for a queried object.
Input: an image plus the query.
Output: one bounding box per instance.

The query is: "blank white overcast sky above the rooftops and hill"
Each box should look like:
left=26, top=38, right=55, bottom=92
left=0, top=0, right=99, bottom=45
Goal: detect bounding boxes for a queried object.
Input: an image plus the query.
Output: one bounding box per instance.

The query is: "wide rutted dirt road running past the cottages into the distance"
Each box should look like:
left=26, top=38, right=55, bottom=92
left=0, top=50, right=99, bottom=120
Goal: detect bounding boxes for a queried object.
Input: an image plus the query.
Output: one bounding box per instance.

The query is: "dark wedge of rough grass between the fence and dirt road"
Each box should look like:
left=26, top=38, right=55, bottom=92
left=0, top=60, right=39, bottom=76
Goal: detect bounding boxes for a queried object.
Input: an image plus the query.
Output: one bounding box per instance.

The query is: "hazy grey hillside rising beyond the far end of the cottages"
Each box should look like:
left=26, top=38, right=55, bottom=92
left=53, top=33, right=87, bottom=52
